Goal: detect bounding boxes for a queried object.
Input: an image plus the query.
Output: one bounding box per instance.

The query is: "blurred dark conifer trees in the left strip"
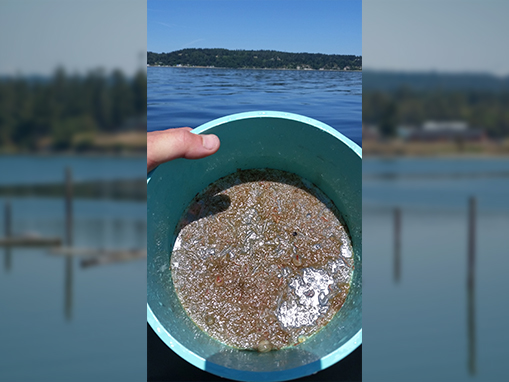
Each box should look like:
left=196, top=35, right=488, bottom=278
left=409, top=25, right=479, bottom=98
left=0, top=68, right=147, bottom=150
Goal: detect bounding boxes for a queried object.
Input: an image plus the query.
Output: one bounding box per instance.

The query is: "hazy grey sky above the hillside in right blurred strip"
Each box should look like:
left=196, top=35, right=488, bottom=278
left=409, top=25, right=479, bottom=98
left=362, top=0, right=509, bottom=75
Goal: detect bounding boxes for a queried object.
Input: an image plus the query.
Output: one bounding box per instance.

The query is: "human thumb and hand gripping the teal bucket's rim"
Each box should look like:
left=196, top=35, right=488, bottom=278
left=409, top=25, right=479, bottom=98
left=147, top=127, right=220, bottom=172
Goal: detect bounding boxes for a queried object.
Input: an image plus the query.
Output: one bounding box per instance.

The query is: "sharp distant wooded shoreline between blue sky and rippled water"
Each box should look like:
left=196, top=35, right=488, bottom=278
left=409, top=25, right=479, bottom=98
left=147, top=49, right=362, bottom=70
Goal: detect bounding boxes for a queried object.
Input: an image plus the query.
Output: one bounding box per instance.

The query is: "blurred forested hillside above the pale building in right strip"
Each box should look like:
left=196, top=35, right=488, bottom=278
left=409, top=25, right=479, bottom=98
left=362, top=71, right=509, bottom=138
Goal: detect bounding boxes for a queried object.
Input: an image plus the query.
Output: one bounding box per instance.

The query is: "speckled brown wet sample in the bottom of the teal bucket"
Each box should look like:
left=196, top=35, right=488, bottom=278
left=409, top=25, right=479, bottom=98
left=171, top=169, right=353, bottom=352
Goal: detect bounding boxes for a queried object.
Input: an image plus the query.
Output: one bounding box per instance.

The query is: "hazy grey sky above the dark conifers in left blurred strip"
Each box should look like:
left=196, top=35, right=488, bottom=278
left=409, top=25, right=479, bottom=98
left=0, top=0, right=147, bottom=75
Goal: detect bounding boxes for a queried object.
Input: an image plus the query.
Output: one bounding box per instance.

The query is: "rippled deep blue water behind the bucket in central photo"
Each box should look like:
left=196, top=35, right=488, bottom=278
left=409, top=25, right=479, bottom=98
left=147, top=67, right=362, bottom=145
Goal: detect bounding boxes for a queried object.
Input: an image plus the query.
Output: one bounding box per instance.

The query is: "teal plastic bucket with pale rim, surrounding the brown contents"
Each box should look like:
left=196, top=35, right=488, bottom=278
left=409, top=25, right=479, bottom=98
left=147, top=111, right=362, bottom=381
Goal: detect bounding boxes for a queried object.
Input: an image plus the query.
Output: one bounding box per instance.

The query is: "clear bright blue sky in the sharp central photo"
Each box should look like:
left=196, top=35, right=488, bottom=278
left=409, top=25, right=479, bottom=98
left=147, top=0, right=362, bottom=55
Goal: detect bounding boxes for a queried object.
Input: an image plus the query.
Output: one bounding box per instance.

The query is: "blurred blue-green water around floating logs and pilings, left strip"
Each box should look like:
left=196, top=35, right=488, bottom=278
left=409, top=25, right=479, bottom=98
left=0, top=156, right=146, bottom=381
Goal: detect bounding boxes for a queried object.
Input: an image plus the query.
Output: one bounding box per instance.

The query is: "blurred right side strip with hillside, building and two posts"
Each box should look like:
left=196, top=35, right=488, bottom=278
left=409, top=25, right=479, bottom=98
left=362, top=0, right=509, bottom=381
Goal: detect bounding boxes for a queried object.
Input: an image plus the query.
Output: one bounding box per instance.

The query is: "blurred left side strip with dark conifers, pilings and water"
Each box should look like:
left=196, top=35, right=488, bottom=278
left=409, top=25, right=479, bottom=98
left=0, top=0, right=147, bottom=381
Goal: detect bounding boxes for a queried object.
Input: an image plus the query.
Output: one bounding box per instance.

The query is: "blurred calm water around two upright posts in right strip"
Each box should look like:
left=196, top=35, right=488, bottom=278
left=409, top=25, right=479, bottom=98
left=363, top=159, right=509, bottom=381
